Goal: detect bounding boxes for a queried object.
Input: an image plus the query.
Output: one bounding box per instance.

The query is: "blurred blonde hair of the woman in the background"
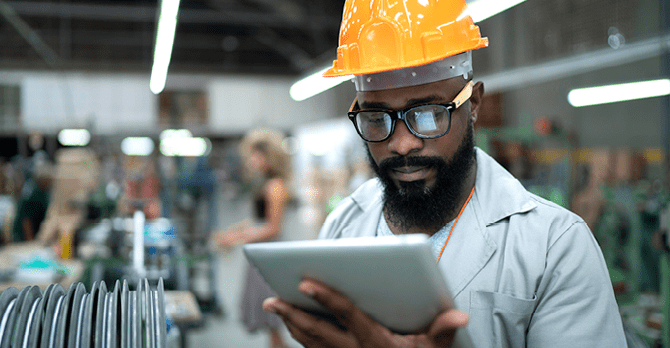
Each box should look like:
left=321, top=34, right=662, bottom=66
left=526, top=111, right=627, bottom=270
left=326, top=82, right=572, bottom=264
left=239, top=129, right=291, bottom=182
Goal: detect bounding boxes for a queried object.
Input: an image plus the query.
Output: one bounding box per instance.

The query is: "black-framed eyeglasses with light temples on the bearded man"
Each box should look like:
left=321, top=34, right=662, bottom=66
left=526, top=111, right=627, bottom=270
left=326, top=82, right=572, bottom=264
left=347, top=81, right=474, bottom=143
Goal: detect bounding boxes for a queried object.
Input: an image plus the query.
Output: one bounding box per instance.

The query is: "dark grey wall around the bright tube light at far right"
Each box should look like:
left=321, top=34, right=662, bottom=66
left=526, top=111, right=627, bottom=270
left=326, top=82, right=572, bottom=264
left=504, top=57, right=664, bottom=149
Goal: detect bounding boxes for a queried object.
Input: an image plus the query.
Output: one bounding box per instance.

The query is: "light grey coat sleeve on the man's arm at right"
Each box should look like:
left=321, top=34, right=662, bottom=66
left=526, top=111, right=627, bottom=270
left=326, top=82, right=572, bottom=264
left=527, top=221, right=626, bottom=348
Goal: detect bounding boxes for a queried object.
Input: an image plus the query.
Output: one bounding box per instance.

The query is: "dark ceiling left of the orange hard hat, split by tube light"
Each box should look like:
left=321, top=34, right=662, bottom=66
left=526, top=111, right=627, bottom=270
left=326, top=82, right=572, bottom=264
left=0, top=0, right=344, bottom=76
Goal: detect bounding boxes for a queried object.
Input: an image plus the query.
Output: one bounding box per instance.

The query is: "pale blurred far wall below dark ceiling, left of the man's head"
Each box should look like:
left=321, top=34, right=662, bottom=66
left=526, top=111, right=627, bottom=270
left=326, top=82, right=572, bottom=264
left=0, top=72, right=347, bottom=134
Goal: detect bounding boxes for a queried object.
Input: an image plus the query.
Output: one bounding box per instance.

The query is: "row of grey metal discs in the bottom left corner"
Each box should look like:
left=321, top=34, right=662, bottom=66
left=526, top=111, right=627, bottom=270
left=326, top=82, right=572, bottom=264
left=0, top=279, right=167, bottom=348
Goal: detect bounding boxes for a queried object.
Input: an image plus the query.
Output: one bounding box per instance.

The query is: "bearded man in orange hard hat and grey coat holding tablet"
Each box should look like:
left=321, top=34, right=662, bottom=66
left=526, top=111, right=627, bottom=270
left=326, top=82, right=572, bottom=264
left=264, top=0, right=626, bottom=348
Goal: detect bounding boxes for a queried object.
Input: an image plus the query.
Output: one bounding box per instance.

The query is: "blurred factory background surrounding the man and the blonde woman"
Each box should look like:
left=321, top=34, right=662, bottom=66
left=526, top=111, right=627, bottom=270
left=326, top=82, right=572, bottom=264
left=0, top=0, right=670, bottom=348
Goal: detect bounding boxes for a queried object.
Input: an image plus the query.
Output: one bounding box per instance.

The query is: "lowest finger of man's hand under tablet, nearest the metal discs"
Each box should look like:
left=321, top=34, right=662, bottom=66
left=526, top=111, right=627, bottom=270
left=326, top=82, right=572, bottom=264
left=263, top=298, right=358, bottom=348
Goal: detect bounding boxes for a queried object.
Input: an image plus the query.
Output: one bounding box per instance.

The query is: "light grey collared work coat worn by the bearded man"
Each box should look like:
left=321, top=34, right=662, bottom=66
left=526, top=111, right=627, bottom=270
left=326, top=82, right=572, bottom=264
left=319, top=149, right=626, bottom=348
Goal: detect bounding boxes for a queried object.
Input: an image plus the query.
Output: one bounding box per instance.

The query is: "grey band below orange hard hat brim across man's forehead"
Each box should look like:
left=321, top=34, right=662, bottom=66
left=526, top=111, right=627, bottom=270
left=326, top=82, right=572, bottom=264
left=354, top=51, right=472, bottom=92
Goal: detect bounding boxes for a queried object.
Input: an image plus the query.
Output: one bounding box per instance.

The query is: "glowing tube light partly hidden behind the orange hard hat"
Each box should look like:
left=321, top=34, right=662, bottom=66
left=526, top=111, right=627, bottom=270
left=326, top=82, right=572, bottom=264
left=289, top=0, right=526, bottom=101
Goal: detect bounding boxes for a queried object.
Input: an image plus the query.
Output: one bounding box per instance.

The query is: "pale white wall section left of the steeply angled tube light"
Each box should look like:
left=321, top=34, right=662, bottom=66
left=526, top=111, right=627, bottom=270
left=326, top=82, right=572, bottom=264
left=20, top=74, right=157, bottom=133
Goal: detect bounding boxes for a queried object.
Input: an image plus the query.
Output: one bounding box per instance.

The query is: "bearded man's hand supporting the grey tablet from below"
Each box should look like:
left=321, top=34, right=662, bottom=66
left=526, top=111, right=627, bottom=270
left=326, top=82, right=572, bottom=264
left=263, top=280, right=468, bottom=348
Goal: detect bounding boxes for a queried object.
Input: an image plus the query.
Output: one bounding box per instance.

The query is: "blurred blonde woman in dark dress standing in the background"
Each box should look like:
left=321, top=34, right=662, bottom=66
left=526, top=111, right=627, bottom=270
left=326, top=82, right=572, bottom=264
left=217, top=130, right=290, bottom=348
